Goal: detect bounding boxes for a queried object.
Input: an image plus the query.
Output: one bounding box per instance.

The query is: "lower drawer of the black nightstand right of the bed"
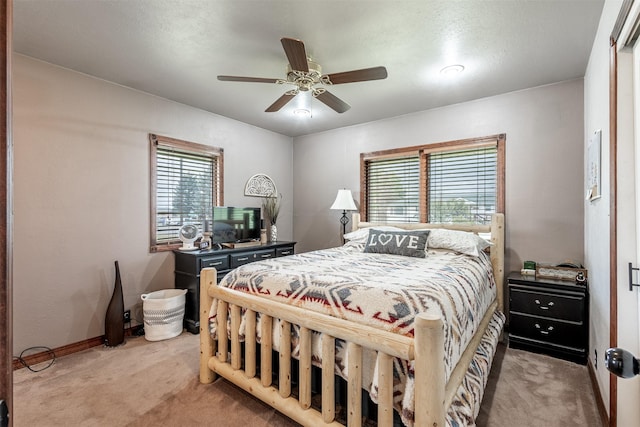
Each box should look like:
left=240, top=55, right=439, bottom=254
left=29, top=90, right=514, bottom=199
left=509, top=313, right=586, bottom=349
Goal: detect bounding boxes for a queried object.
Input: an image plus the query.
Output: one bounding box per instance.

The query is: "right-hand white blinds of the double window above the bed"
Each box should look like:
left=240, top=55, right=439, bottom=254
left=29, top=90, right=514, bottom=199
left=426, top=146, right=498, bottom=224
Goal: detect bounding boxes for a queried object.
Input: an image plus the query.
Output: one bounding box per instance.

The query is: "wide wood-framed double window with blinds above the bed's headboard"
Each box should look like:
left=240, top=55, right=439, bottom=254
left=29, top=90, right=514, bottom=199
left=361, top=135, right=505, bottom=224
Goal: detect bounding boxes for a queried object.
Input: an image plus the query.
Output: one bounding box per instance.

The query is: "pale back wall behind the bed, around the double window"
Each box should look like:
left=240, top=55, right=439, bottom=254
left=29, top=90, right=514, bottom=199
left=293, top=79, right=584, bottom=280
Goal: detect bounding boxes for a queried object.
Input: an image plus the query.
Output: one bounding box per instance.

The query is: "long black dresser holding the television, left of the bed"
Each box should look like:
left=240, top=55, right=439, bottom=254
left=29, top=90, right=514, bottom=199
left=173, top=242, right=296, bottom=334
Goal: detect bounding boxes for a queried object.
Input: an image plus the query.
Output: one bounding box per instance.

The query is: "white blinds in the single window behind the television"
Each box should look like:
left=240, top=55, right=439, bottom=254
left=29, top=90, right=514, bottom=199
left=156, top=146, right=218, bottom=243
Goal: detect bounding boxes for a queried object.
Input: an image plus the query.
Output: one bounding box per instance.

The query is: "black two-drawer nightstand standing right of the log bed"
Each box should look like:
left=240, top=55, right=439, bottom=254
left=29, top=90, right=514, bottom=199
left=508, top=273, right=589, bottom=364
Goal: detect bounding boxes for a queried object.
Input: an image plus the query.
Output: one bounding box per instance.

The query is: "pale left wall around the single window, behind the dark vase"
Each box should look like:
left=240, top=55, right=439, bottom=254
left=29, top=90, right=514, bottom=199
left=13, top=55, right=293, bottom=353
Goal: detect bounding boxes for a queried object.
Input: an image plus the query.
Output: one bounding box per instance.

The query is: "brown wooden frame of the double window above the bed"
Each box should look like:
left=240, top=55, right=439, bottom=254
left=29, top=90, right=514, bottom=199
left=360, top=134, right=506, bottom=223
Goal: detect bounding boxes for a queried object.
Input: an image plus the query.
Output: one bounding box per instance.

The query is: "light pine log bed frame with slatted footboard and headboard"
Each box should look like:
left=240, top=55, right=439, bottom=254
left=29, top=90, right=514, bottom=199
left=200, top=214, right=504, bottom=427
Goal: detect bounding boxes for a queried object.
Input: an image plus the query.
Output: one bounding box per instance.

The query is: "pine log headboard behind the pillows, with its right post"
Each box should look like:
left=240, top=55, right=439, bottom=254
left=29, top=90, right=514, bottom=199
left=352, top=213, right=504, bottom=311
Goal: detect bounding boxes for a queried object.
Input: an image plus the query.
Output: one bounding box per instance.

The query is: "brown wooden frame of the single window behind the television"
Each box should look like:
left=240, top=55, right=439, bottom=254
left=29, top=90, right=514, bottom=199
left=149, top=133, right=224, bottom=253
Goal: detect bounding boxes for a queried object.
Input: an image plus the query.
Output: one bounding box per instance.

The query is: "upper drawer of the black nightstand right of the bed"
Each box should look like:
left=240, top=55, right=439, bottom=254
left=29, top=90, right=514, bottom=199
left=509, top=287, right=585, bottom=322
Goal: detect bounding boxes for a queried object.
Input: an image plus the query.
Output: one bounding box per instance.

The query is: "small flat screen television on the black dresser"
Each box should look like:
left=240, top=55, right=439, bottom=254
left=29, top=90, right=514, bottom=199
left=211, top=206, right=260, bottom=243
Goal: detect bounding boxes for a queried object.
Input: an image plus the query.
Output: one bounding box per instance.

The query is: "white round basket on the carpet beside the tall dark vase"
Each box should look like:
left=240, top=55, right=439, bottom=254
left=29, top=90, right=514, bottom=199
left=140, top=289, right=187, bottom=341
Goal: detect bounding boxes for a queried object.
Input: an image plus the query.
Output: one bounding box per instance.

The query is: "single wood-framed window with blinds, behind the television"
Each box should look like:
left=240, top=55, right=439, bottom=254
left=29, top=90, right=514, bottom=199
left=149, top=134, right=223, bottom=252
